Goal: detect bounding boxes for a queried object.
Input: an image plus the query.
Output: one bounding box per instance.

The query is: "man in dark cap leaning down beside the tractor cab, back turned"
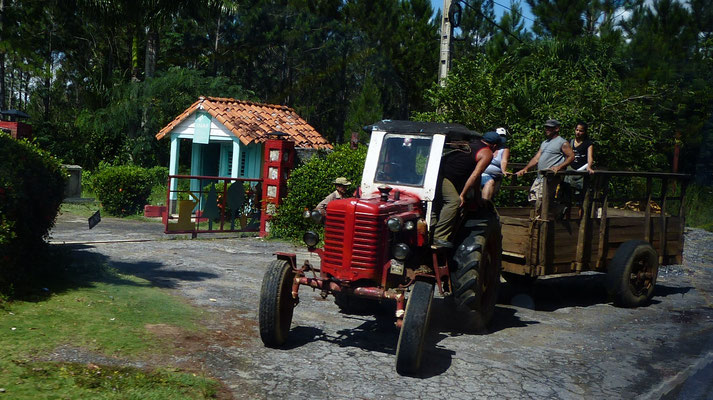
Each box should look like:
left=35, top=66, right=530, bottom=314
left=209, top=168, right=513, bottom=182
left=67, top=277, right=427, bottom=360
left=431, top=132, right=505, bottom=248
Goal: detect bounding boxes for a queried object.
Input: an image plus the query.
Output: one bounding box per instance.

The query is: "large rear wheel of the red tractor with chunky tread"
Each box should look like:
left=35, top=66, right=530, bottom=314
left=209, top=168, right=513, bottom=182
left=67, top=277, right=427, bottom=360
left=451, top=211, right=502, bottom=326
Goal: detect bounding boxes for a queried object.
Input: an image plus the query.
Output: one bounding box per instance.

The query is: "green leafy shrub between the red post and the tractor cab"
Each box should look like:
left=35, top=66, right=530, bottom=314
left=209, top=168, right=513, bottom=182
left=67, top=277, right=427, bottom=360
left=270, top=145, right=366, bottom=239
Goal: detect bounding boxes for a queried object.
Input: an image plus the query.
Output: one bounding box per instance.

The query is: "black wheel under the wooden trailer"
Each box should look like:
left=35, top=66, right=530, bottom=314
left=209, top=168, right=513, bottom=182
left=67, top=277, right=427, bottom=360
left=607, top=240, right=659, bottom=307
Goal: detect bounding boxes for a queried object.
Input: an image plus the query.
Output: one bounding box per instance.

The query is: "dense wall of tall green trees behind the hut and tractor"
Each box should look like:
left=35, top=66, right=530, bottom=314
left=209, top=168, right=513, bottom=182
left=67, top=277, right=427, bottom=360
left=0, top=0, right=713, bottom=177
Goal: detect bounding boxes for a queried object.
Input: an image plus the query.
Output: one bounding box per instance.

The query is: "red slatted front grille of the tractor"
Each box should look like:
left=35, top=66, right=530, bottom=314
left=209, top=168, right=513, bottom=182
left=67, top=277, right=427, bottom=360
left=322, top=209, right=386, bottom=269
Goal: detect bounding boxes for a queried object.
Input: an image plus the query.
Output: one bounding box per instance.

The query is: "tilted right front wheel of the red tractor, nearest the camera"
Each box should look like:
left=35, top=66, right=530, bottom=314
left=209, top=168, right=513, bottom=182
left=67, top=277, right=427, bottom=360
left=396, top=281, right=434, bottom=375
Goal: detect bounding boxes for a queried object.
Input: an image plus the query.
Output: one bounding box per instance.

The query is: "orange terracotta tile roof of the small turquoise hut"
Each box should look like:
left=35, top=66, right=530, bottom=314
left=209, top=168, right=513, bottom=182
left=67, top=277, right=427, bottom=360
left=156, top=97, right=332, bottom=149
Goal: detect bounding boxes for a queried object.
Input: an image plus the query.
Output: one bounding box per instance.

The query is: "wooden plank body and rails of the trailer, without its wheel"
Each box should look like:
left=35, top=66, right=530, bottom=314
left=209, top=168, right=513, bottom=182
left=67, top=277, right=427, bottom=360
left=499, top=171, right=690, bottom=276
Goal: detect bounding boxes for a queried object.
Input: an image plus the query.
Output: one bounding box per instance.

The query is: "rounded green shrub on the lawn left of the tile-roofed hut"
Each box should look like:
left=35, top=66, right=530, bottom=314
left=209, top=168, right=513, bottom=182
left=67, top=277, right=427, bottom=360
left=91, top=164, right=155, bottom=216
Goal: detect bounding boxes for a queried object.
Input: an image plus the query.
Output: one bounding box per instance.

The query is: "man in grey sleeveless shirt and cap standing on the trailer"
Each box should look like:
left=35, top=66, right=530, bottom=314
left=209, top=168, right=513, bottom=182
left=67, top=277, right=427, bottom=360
left=516, top=119, right=574, bottom=202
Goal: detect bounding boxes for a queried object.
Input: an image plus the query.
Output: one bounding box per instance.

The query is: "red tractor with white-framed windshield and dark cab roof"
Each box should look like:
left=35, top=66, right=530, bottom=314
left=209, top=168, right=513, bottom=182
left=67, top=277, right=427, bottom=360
left=259, top=120, right=502, bottom=374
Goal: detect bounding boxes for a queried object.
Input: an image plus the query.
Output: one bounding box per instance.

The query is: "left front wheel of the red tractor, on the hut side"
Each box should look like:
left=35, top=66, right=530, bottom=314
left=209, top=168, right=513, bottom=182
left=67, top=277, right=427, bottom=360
left=258, top=260, right=297, bottom=347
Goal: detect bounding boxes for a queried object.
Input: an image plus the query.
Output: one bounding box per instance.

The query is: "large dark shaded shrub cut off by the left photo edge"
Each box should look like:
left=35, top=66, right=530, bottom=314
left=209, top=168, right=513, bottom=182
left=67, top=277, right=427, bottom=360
left=0, top=133, right=67, bottom=291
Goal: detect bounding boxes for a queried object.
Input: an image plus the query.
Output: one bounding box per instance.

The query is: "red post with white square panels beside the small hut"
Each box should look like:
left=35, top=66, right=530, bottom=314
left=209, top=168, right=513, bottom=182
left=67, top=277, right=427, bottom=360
left=260, top=135, right=295, bottom=237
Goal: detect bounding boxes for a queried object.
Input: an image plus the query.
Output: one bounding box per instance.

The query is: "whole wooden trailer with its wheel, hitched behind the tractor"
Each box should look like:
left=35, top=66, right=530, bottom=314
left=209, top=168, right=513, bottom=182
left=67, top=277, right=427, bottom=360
left=498, top=171, right=689, bottom=307
